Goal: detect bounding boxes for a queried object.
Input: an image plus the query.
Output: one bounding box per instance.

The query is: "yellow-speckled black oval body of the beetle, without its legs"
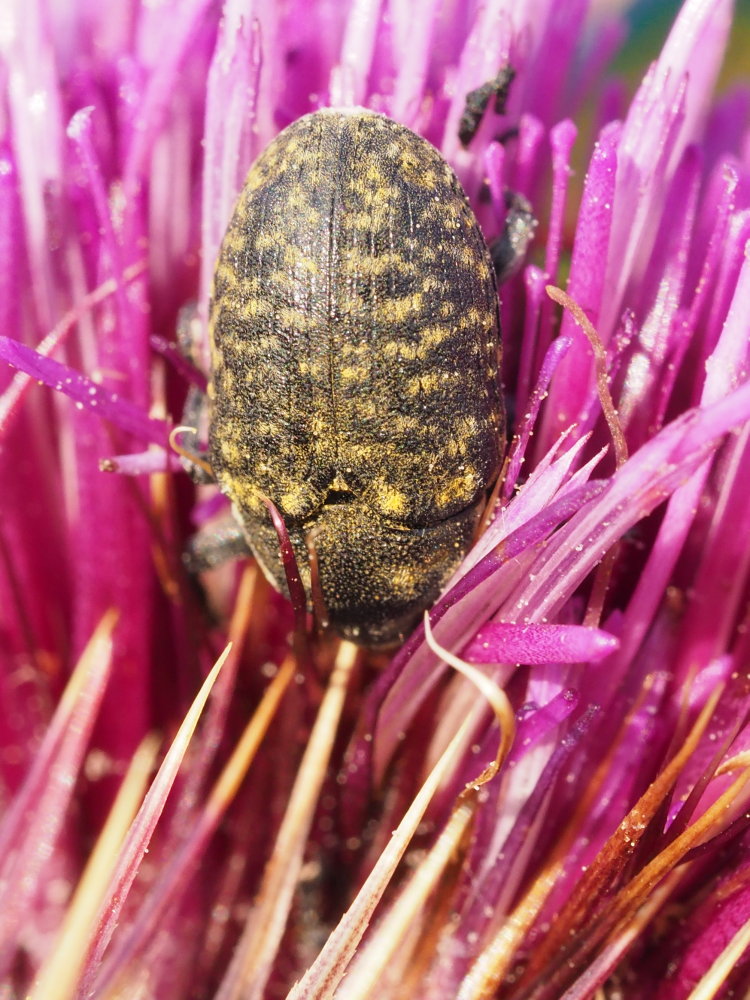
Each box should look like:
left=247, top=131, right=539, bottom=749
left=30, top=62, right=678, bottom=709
left=209, top=109, right=504, bottom=645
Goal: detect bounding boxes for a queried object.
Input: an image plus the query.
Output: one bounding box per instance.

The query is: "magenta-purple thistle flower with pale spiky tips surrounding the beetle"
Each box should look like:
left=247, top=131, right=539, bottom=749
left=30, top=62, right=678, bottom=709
left=0, top=0, right=750, bottom=1000
